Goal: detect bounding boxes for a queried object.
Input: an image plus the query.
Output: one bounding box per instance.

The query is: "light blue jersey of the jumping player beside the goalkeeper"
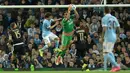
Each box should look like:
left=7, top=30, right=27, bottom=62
left=42, top=19, right=51, bottom=37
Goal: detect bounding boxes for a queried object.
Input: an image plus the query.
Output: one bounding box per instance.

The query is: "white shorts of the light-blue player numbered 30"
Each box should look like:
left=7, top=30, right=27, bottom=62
left=103, top=42, right=115, bottom=52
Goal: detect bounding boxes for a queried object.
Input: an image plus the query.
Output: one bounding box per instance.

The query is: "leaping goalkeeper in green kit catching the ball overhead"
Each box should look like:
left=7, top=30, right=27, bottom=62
left=55, top=5, right=79, bottom=65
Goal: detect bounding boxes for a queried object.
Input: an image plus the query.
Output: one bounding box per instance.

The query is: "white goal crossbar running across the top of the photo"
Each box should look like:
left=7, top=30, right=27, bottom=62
left=0, top=0, right=130, bottom=9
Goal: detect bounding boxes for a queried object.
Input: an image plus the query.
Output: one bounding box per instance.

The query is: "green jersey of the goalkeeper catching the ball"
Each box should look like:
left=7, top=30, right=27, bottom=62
left=62, top=15, right=74, bottom=32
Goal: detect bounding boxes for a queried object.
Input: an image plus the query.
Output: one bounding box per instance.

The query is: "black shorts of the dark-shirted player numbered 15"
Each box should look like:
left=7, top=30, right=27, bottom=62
left=13, top=44, right=25, bottom=55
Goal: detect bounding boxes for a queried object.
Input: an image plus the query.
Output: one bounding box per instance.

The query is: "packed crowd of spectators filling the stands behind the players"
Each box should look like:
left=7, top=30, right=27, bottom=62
left=0, top=0, right=130, bottom=69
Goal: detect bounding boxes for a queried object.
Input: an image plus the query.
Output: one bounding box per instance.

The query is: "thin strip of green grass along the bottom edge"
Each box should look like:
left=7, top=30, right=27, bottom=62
left=0, top=70, right=130, bottom=73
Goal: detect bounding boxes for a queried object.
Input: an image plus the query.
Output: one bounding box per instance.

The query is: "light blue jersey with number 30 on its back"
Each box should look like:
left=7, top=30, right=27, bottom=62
left=102, top=14, right=120, bottom=43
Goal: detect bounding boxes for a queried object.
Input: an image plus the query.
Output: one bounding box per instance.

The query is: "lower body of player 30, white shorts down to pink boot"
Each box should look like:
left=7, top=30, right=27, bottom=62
left=103, top=42, right=120, bottom=72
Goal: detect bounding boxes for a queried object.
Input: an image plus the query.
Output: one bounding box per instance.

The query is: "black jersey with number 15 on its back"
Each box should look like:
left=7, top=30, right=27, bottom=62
left=10, top=29, right=23, bottom=44
